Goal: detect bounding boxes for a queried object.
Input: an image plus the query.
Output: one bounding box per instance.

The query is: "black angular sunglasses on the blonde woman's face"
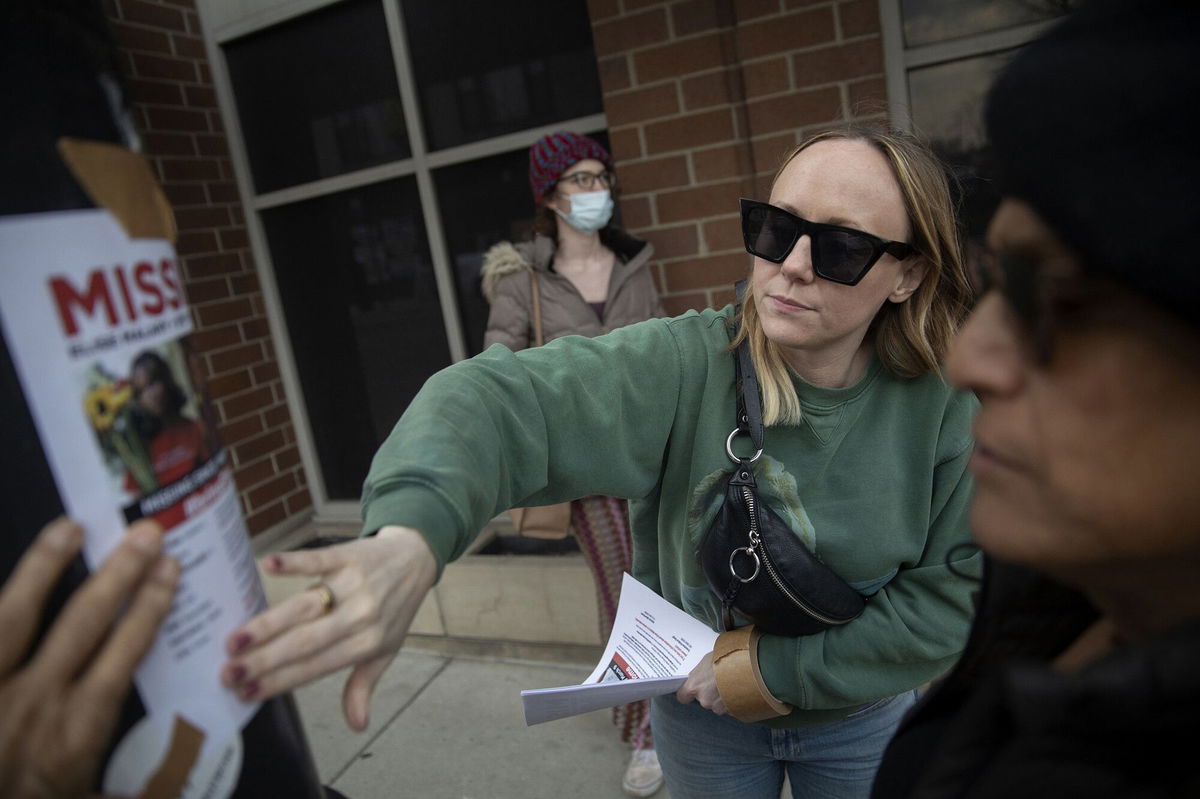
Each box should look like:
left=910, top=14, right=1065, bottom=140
left=739, top=198, right=916, bottom=286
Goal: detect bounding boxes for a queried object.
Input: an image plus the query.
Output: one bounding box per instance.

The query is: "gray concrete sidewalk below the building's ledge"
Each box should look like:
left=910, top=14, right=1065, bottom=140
left=295, top=648, right=670, bottom=799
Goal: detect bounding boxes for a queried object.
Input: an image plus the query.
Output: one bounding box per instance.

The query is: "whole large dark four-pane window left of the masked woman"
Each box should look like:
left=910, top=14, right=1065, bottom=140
left=217, top=0, right=607, bottom=506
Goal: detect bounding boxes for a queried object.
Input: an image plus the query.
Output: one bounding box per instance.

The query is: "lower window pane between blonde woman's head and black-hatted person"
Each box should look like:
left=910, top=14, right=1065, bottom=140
left=908, top=50, right=1016, bottom=238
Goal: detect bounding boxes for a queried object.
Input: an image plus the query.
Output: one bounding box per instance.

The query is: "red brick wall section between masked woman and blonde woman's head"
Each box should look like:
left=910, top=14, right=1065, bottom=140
left=588, top=0, right=887, bottom=313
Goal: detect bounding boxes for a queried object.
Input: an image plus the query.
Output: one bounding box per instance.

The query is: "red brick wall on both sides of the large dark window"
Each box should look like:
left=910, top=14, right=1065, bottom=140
left=104, top=0, right=884, bottom=533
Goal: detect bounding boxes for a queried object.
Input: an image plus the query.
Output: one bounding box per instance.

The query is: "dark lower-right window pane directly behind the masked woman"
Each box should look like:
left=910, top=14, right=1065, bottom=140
left=433, top=131, right=609, bottom=354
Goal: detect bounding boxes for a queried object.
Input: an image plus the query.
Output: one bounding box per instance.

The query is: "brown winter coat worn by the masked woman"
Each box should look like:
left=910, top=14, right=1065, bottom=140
left=482, top=230, right=664, bottom=350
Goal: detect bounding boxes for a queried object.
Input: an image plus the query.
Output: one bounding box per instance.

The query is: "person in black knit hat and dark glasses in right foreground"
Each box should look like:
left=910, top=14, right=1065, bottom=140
left=875, top=0, right=1200, bottom=799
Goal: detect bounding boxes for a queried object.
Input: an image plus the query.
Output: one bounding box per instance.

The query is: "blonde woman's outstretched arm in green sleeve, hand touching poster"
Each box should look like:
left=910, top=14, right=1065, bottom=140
left=222, top=314, right=679, bottom=729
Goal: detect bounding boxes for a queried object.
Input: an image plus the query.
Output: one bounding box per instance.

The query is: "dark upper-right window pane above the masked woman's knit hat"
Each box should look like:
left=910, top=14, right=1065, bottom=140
left=401, top=0, right=604, bottom=150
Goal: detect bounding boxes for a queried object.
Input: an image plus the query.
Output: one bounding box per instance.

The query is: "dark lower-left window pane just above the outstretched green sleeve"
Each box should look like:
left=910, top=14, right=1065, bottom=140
left=262, top=178, right=450, bottom=499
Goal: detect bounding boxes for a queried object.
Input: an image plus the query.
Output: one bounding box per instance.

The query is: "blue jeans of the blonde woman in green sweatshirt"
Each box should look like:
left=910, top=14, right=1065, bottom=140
left=650, top=691, right=917, bottom=799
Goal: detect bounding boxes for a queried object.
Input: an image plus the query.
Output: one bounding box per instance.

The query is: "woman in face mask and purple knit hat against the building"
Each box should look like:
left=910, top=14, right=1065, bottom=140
left=482, top=131, right=662, bottom=797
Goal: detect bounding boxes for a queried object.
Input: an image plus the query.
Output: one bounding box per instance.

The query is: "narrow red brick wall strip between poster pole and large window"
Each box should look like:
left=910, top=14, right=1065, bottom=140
left=104, top=0, right=312, bottom=534
